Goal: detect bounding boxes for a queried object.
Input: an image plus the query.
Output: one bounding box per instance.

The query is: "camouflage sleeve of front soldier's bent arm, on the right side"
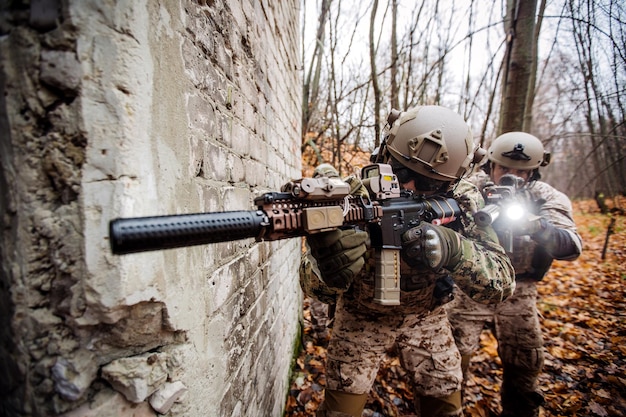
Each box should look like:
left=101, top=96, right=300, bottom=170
left=450, top=181, right=515, bottom=304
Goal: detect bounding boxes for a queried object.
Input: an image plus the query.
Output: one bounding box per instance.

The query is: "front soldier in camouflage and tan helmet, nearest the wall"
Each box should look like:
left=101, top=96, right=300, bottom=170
left=301, top=106, right=514, bottom=417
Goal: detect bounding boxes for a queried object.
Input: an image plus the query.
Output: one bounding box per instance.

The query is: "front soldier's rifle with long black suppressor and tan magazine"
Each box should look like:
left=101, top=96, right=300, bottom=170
left=109, top=164, right=460, bottom=305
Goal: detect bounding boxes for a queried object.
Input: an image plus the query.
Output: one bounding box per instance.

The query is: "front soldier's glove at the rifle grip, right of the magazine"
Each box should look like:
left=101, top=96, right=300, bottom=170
left=402, top=223, right=462, bottom=271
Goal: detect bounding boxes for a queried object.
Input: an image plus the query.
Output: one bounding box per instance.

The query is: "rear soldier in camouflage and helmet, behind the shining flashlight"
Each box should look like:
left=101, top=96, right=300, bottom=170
left=447, top=132, right=582, bottom=417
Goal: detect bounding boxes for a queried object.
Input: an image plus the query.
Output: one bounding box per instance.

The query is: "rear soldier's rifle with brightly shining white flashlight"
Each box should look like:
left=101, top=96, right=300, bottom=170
left=474, top=174, right=536, bottom=253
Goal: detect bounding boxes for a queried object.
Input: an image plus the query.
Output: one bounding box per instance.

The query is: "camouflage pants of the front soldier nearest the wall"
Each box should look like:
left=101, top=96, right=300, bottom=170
left=326, top=305, right=463, bottom=397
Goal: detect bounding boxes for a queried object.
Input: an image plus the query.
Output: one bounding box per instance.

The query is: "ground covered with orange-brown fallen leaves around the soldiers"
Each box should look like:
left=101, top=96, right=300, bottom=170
left=285, top=200, right=626, bottom=417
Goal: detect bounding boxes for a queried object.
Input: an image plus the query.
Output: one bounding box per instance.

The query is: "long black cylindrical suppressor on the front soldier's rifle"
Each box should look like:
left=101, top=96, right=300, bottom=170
left=109, top=210, right=268, bottom=255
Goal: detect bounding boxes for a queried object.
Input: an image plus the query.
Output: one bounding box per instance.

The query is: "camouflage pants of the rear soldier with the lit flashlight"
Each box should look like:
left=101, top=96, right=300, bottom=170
left=446, top=281, right=543, bottom=392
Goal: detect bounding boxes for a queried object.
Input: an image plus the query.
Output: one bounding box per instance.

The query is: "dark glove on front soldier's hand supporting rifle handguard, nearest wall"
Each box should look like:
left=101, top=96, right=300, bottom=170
left=306, top=229, right=368, bottom=290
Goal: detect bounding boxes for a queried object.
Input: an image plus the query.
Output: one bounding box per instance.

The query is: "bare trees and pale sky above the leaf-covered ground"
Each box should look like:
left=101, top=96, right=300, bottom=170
left=294, top=0, right=626, bottom=199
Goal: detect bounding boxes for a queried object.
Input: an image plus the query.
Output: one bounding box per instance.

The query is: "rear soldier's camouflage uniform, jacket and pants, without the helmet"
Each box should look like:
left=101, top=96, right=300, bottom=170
left=447, top=172, right=582, bottom=416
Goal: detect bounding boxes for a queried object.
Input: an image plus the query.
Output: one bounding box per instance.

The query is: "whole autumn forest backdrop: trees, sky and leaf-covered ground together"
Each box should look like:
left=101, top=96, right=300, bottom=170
left=286, top=0, right=626, bottom=417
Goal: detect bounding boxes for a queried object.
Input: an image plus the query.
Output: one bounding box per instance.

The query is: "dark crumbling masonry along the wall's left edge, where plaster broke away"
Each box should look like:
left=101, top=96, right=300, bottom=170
left=0, top=6, right=184, bottom=417
